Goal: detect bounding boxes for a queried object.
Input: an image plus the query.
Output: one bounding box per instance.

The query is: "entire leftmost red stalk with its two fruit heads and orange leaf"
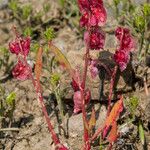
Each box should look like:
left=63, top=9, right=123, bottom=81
left=9, top=28, right=67, bottom=150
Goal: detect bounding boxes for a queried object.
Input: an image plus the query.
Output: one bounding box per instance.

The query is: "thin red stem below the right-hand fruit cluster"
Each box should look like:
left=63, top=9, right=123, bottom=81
left=107, top=66, right=118, bottom=116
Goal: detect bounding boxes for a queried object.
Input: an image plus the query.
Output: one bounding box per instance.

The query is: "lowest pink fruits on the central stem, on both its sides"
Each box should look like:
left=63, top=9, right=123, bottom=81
left=73, top=89, right=91, bottom=114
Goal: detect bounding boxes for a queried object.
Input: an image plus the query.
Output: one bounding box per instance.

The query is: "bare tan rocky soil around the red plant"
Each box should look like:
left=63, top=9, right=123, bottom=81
left=0, top=0, right=150, bottom=150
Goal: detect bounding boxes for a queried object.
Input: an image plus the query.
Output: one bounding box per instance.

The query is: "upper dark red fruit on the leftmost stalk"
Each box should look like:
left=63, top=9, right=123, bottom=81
left=9, top=37, right=30, bottom=56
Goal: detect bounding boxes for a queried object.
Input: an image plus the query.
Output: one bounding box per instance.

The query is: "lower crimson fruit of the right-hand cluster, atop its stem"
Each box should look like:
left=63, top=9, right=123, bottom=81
left=114, top=50, right=130, bottom=71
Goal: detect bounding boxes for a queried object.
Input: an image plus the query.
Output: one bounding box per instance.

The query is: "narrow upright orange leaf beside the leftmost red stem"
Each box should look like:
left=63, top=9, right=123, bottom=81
left=34, top=47, right=43, bottom=82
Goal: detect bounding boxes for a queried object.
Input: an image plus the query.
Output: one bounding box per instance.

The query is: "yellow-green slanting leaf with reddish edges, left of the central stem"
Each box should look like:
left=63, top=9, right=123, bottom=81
left=49, top=43, right=73, bottom=77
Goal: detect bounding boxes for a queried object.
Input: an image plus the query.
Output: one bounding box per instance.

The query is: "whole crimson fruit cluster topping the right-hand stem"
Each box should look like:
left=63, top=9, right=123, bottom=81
left=114, top=27, right=135, bottom=71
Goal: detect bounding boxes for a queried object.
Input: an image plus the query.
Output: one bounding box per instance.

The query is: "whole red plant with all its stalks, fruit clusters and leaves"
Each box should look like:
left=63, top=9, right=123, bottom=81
left=9, top=0, right=137, bottom=150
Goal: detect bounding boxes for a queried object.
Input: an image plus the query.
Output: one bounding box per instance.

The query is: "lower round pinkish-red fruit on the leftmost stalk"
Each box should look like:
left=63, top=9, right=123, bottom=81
left=12, top=60, right=31, bottom=80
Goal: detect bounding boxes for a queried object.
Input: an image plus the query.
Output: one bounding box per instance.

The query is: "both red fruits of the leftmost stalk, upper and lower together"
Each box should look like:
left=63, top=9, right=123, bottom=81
left=9, top=37, right=31, bottom=80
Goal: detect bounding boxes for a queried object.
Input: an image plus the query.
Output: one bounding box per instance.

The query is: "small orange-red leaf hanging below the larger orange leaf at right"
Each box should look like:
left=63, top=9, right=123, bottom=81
left=107, top=122, right=118, bottom=143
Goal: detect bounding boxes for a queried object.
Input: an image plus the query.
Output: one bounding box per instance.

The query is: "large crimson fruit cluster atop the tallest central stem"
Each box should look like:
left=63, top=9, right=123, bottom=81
left=78, top=0, right=107, bottom=50
